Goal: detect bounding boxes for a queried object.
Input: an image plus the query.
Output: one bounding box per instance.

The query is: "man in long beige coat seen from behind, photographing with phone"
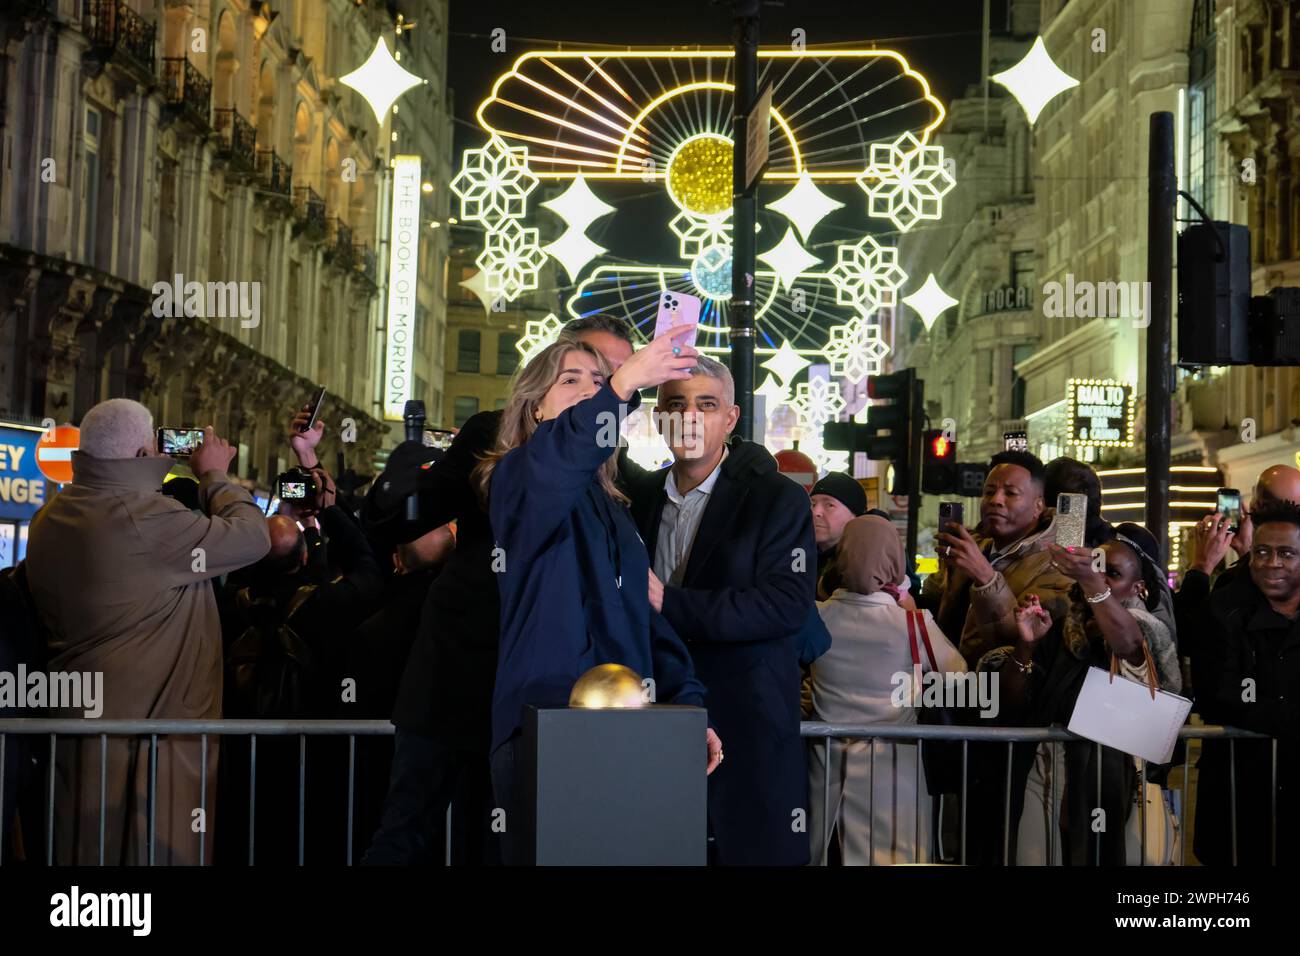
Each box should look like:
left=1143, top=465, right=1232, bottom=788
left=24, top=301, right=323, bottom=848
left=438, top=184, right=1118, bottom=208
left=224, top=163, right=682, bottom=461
left=27, top=398, right=270, bottom=865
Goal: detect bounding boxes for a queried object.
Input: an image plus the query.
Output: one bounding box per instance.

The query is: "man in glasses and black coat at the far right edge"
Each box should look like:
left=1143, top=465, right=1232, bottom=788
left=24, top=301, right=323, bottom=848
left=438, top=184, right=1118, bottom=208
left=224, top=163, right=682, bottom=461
left=1184, top=502, right=1300, bottom=866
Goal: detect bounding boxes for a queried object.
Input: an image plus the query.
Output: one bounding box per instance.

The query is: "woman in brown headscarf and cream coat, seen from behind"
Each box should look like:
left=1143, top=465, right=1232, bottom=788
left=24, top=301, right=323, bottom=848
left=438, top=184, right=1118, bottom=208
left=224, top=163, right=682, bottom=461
left=810, top=515, right=966, bottom=866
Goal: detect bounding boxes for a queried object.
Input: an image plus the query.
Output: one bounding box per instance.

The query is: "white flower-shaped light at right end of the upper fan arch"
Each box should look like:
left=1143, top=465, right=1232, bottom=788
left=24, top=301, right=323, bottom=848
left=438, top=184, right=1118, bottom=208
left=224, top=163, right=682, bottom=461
left=857, top=131, right=957, bottom=233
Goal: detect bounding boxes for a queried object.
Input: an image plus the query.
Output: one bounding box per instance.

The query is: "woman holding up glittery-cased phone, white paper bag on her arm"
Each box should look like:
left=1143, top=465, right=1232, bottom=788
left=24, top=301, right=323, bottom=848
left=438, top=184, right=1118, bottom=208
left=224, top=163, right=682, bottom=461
left=979, top=523, right=1182, bottom=866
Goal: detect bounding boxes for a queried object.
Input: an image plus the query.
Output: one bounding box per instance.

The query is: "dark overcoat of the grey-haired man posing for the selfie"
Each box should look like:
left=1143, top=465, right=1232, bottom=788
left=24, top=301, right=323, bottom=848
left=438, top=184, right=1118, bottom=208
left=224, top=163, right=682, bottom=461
left=632, top=438, right=816, bottom=865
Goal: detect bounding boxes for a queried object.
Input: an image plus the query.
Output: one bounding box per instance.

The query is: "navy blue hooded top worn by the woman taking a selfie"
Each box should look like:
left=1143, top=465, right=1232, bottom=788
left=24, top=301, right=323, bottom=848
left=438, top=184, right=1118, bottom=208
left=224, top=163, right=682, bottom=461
left=488, top=384, right=705, bottom=760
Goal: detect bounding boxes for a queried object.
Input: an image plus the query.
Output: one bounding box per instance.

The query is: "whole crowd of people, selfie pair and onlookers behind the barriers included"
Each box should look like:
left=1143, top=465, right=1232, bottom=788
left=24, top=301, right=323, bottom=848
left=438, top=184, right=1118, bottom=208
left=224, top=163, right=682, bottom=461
left=0, top=316, right=1300, bottom=865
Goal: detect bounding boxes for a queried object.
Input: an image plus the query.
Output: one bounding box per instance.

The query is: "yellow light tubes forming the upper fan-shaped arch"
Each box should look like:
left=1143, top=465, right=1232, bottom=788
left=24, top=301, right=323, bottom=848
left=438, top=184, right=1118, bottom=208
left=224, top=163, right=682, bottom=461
left=475, top=47, right=946, bottom=182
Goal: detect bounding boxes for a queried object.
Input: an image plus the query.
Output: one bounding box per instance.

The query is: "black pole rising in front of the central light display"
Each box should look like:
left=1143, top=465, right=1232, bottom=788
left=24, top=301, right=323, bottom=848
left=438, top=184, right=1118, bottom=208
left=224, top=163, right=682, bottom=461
left=728, top=0, right=761, bottom=441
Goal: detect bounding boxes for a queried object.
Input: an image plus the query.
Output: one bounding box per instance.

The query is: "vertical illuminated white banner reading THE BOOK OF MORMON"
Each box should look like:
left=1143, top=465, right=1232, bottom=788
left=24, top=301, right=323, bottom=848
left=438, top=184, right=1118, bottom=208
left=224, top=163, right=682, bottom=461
left=384, top=155, right=420, bottom=421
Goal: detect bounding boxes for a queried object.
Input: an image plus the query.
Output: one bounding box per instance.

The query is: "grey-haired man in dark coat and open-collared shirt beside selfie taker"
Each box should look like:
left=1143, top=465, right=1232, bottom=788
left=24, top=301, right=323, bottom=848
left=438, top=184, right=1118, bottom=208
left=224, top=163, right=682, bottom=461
left=632, top=358, right=816, bottom=865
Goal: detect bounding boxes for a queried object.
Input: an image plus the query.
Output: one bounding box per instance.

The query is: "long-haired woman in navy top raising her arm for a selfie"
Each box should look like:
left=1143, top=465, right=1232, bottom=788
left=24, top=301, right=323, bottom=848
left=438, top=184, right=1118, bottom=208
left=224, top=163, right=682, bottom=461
left=476, top=330, right=722, bottom=862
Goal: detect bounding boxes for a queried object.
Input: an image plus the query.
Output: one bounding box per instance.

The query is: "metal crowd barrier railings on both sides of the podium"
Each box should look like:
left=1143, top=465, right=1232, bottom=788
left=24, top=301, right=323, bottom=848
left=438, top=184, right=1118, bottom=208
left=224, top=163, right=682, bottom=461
left=0, top=718, right=1278, bottom=866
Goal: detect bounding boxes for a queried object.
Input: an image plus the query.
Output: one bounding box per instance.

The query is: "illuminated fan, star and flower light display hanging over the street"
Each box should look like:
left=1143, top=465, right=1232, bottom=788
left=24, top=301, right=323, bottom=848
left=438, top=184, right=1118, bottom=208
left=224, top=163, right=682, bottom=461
left=454, top=48, right=953, bottom=476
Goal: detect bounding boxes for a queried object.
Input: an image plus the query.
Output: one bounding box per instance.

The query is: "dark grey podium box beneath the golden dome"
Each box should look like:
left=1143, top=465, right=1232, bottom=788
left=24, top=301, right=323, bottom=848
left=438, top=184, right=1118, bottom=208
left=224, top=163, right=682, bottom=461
left=519, top=705, right=709, bottom=866
